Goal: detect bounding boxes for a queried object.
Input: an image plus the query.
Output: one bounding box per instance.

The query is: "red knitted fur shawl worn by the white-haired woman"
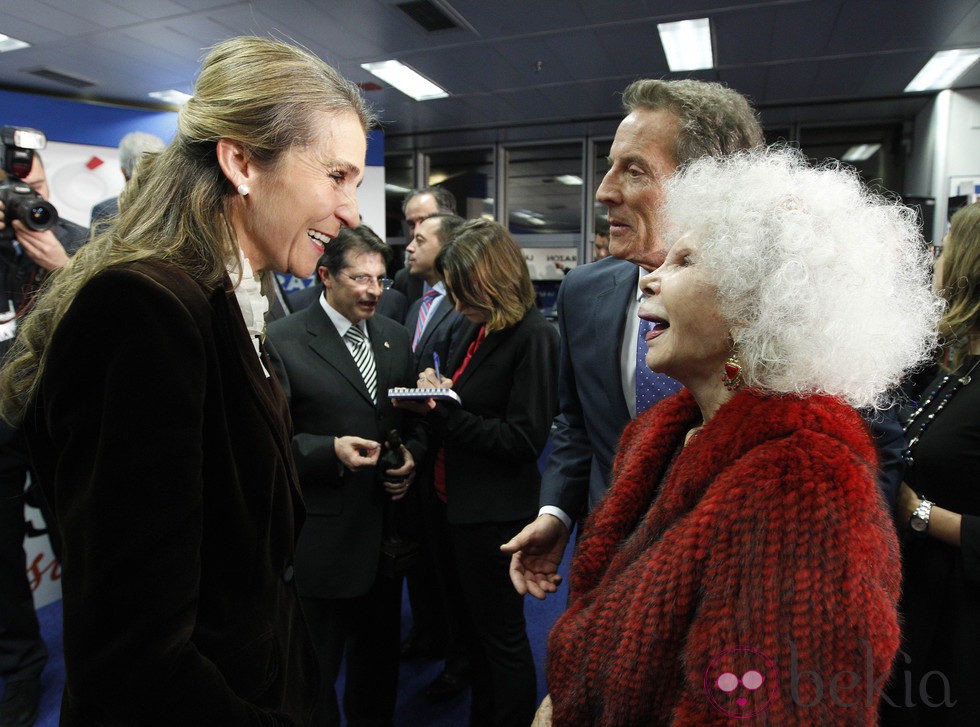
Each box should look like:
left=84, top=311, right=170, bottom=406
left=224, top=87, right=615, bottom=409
left=548, top=391, right=901, bottom=727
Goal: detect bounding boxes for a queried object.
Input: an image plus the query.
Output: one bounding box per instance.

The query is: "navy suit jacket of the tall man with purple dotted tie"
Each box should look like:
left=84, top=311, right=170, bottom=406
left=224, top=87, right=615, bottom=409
left=540, top=257, right=639, bottom=519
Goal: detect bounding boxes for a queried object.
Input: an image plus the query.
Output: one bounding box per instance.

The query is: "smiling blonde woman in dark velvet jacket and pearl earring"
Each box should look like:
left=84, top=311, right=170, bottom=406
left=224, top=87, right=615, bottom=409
left=0, top=38, right=371, bottom=725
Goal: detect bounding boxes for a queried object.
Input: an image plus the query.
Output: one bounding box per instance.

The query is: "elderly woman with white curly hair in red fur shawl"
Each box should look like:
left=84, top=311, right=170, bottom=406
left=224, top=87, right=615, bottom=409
left=536, top=149, right=941, bottom=726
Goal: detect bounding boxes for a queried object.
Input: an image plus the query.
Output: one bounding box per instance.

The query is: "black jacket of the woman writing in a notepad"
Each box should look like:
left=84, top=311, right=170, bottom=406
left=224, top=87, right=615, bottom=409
left=432, top=308, right=558, bottom=524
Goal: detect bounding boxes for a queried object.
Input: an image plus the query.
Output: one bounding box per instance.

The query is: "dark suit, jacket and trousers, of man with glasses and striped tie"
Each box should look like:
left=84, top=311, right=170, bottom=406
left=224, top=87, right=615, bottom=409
left=266, top=304, right=424, bottom=724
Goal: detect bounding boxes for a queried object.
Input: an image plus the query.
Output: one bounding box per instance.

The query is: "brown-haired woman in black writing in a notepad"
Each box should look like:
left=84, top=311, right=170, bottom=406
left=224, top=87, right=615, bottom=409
left=406, top=220, right=558, bottom=727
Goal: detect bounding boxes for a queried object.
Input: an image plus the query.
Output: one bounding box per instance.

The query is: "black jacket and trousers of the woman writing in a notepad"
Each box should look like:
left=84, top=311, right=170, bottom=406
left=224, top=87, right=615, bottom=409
left=431, top=308, right=558, bottom=725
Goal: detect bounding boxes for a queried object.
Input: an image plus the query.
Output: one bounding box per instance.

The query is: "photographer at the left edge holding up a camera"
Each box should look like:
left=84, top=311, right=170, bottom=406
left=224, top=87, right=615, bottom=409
left=0, top=152, right=88, bottom=725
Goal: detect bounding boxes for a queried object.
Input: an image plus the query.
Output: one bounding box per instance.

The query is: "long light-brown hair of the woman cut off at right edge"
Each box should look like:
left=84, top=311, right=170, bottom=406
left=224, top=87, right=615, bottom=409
left=939, top=202, right=980, bottom=371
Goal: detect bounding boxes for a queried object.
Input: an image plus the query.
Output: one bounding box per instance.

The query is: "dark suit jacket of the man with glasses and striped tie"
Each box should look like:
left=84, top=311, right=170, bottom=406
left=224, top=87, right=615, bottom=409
left=266, top=304, right=424, bottom=599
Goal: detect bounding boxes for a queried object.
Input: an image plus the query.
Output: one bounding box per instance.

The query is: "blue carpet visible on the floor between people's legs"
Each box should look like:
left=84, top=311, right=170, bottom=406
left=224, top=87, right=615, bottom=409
left=0, top=544, right=572, bottom=727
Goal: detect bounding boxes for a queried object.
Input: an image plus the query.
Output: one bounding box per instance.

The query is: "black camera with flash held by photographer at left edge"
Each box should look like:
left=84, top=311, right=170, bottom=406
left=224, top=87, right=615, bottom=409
left=0, top=126, right=58, bottom=240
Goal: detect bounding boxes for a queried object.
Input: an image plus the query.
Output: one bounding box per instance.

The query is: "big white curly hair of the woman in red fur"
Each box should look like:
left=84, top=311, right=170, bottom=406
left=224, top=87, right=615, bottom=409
left=662, top=147, right=943, bottom=408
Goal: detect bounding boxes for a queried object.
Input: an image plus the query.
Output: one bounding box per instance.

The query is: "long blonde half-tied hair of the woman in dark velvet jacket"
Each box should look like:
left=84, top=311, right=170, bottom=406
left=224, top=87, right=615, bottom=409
left=0, top=37, right=373, bottom=424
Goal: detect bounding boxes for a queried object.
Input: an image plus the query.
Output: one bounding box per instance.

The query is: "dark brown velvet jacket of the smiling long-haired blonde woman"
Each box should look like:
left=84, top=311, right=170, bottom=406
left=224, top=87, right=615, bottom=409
left=24, top=262, right=318, bottom=727
